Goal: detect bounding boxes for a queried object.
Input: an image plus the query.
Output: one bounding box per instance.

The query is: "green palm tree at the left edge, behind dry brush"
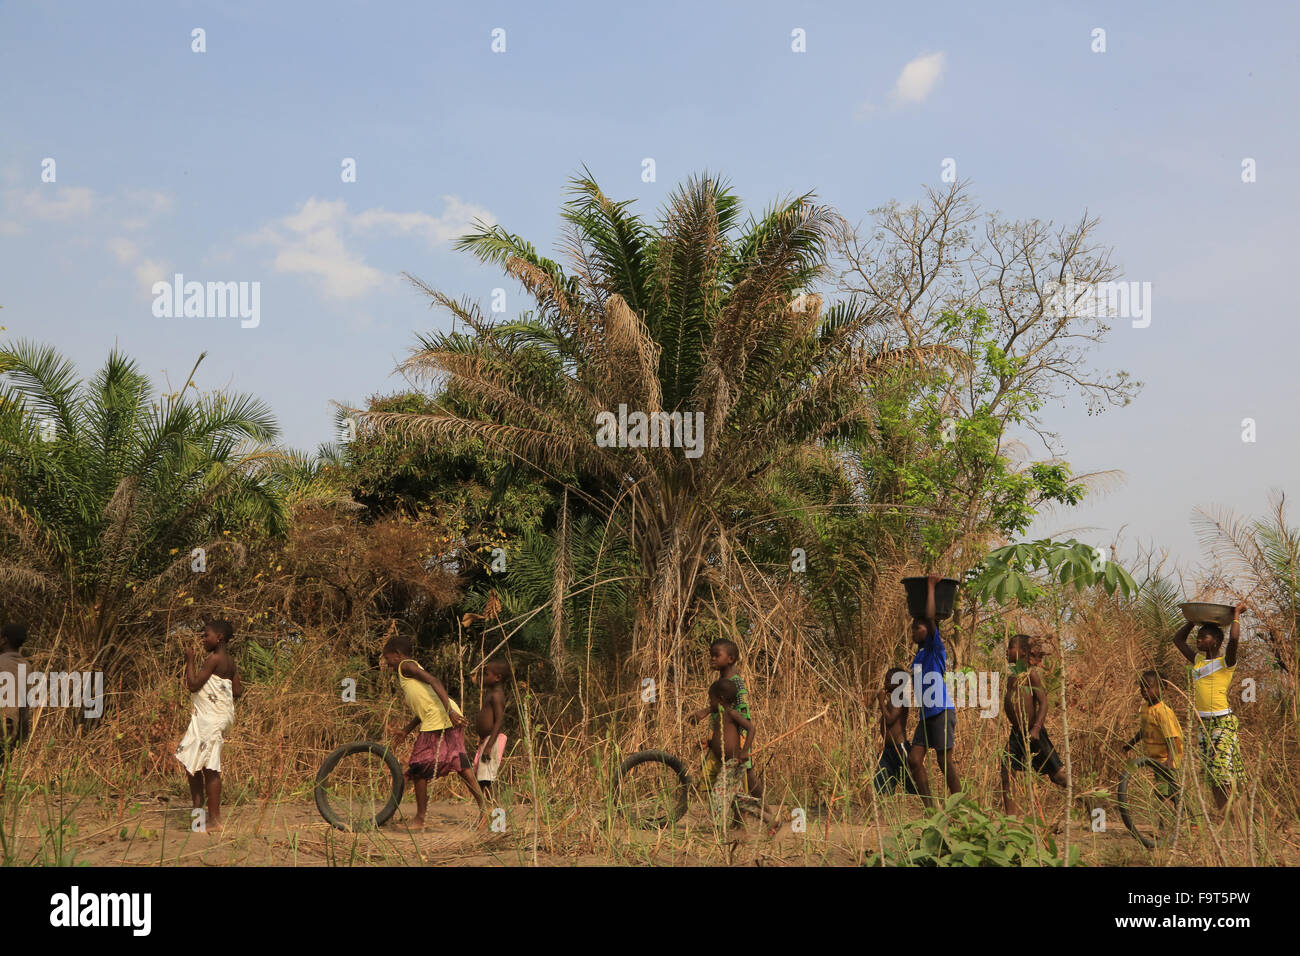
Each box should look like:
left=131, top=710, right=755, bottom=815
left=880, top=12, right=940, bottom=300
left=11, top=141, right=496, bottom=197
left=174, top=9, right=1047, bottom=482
left=0, top=342, right=286, bottom=662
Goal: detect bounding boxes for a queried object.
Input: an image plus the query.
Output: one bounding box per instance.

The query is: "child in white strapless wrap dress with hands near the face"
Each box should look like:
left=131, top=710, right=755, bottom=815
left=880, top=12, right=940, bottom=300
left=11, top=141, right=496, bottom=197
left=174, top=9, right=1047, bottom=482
left=176, top=620, right=243, bottom=832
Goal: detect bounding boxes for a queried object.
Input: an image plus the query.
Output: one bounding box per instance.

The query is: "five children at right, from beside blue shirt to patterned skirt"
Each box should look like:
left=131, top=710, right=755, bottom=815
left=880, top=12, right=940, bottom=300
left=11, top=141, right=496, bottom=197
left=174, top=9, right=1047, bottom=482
left=875, top=575, right=1245, bottom=814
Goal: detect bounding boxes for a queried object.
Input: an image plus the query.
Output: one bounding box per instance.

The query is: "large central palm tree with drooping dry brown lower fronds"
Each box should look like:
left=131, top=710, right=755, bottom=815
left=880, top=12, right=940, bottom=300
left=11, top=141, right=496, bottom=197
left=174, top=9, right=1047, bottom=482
left=369, top=174, right=946, bottom=675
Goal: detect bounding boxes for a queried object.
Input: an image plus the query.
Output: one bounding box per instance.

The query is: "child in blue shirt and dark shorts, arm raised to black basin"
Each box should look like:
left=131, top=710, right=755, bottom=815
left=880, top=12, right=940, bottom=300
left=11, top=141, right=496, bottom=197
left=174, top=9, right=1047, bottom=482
left=907, top=575, right=962, bottom=808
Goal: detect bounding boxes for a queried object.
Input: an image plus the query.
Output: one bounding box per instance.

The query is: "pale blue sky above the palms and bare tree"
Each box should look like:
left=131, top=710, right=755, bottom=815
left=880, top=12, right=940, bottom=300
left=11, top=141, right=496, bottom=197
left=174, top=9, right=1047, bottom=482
left=0, top=3, right=1300, bottom=563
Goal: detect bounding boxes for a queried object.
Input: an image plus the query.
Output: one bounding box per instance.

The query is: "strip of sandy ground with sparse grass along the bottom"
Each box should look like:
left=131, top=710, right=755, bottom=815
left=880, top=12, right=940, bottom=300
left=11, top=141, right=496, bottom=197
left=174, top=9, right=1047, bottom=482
left=4, top=791, right=1300, bottom=866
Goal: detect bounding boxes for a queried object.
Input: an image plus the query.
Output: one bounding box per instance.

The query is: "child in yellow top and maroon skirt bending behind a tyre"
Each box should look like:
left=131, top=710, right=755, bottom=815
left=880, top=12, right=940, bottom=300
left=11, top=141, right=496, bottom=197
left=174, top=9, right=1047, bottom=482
left=384, top=635, right=488, bottom=830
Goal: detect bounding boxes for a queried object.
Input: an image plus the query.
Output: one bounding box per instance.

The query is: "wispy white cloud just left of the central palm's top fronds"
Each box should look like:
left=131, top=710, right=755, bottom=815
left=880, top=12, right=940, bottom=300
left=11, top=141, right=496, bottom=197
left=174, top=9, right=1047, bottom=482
left=246, top=195, right=493, bottom=299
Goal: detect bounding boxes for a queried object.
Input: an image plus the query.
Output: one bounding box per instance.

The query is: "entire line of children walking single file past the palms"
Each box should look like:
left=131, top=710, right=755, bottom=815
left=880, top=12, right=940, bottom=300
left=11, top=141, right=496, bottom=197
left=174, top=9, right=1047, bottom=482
left=152, top=575, right=1245, bottom=830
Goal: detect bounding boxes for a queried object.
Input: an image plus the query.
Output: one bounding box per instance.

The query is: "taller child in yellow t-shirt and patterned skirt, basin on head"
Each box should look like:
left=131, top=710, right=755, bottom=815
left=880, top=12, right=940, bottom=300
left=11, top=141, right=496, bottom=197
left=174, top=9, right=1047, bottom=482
left=1174, top=601, right=1245, bottom=810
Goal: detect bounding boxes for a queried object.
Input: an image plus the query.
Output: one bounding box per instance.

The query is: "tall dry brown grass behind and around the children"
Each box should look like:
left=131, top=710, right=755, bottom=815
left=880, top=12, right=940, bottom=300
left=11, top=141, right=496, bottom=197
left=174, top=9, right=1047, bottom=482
left=7, top=530, right=1300, bottom=865
